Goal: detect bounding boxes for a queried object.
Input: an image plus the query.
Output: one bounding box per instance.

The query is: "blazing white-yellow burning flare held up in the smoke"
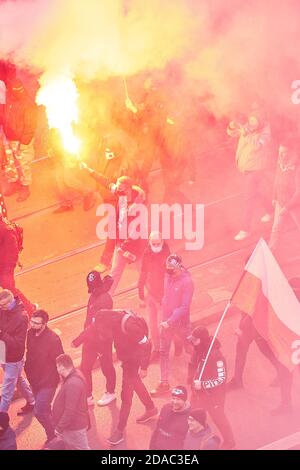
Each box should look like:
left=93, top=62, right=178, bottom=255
left=36, top=76, right=81, bottom=154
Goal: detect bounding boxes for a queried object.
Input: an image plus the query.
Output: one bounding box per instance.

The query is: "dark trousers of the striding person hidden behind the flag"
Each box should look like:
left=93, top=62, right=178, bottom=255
left=234, top=330, right=292, bottom=404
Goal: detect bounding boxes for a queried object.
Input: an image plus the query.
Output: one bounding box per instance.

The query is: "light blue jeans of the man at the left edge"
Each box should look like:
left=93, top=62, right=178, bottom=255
left=0, top=359, right=34, bottom=413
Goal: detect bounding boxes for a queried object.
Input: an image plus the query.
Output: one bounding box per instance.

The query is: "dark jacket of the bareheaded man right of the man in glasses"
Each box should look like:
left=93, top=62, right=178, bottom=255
left=53, top=369, right=90, bottom=433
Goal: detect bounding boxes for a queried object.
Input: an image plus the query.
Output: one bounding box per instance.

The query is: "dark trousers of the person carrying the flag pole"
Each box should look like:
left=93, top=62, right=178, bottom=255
left=191, top=391, right=234, bottom=446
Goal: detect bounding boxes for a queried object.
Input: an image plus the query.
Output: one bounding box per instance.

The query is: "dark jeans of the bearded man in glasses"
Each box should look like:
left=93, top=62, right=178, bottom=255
left=34, top=387, right=56, bottom=440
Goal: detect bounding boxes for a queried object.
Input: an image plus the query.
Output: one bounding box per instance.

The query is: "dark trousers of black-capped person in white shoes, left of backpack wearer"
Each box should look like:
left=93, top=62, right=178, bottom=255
left=80, top=342, right=116, bottom=397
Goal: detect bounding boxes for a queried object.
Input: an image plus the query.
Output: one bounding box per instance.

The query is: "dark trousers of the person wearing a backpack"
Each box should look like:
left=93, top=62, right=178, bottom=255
left=118, top=362, right=154, bottom=431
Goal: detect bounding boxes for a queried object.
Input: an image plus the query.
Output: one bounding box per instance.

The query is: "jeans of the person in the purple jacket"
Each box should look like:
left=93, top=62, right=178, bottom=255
left=160, top=325, right=191, bottom=383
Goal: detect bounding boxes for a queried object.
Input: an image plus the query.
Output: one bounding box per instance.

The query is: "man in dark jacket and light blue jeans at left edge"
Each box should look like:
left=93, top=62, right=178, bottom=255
left=0, top=289, right=34, bottom=413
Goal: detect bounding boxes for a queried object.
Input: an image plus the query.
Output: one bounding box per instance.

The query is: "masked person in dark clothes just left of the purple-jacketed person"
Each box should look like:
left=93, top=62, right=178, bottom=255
left=138, top=231, right=170, bottom=361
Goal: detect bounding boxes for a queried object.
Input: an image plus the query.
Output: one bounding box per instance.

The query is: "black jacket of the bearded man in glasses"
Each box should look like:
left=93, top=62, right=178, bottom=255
left=24, top=327, right=64, bottom=391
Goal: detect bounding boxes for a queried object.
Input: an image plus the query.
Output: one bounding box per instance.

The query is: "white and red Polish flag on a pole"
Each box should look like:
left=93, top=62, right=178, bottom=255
left=231, top=239, right=300, bottom=370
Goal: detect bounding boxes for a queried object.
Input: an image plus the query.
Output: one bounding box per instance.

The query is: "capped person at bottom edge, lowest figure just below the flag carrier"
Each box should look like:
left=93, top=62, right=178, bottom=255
left=183, top=408, right=220, bottom=450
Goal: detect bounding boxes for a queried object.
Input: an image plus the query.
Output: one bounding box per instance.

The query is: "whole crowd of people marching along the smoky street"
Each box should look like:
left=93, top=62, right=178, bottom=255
left=0, top=64, right=300, bottom=450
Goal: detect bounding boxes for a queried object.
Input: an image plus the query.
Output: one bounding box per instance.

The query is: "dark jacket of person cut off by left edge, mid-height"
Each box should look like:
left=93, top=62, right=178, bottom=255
left=0, top=220, right=19, bottom=271
